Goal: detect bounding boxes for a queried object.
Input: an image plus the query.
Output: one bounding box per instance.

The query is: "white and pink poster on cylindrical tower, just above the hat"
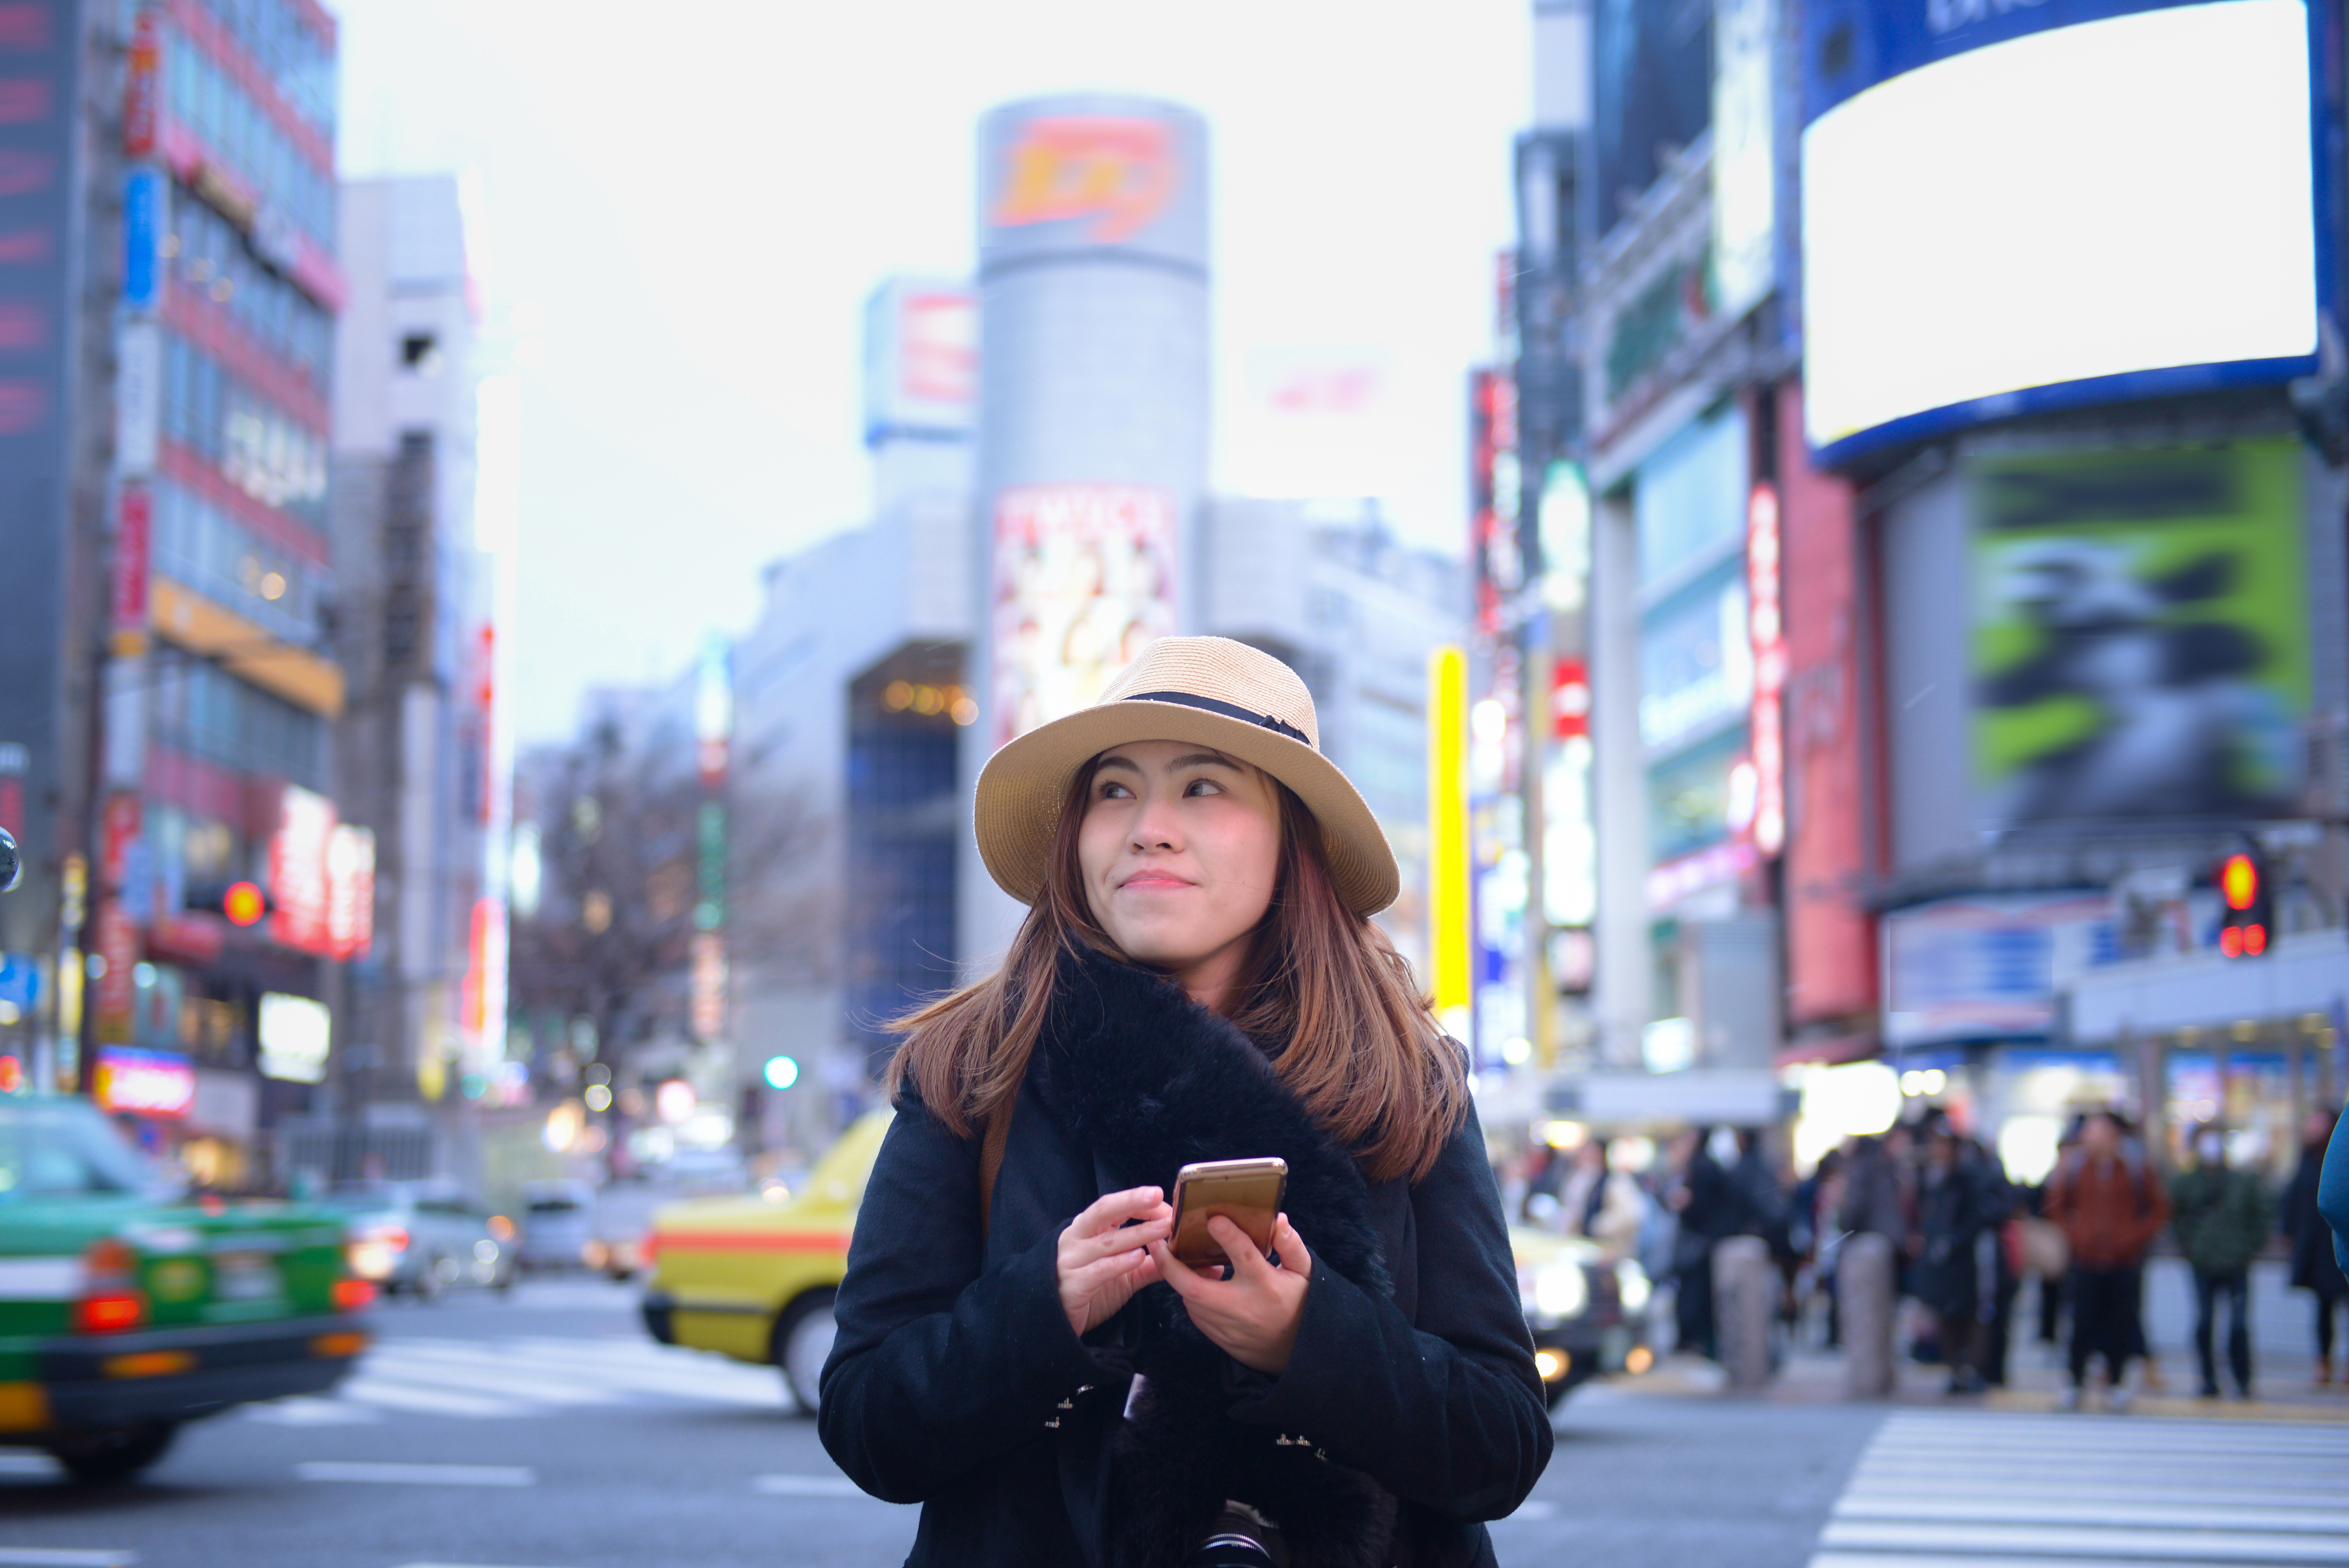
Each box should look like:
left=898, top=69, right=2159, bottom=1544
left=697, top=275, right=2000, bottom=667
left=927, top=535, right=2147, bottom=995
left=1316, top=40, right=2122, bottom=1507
left=994, top=483, right=1177, bottom=747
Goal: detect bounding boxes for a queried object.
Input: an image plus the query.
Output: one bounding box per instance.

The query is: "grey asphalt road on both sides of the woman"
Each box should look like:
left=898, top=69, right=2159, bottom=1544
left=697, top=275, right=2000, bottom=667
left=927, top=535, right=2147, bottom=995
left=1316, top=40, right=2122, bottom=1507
left=0, top=1282, right=1879, bottom=1568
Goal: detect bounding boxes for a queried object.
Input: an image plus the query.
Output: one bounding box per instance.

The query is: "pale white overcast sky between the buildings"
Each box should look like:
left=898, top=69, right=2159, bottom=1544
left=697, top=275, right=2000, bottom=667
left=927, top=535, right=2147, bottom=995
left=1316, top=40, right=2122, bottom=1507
left=331, top=0, right=1531, bottom=739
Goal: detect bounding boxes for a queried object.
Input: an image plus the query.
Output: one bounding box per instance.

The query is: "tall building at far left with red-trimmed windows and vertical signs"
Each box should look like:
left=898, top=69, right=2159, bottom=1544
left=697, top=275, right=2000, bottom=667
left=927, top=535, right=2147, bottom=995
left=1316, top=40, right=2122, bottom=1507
left=0, top=0, right=348, bottom=1183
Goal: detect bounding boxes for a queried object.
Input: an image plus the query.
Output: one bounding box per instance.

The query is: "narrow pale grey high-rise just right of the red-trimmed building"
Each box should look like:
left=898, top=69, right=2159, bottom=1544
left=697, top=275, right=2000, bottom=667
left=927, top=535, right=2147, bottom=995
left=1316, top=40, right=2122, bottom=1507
left=333, top=176, right=486, bottom=1126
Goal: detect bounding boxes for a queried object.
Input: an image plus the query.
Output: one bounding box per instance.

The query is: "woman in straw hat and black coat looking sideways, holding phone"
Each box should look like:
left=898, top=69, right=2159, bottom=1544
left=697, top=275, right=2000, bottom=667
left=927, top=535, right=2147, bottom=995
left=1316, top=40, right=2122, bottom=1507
left=820, top=638, right=1553, bottom=1568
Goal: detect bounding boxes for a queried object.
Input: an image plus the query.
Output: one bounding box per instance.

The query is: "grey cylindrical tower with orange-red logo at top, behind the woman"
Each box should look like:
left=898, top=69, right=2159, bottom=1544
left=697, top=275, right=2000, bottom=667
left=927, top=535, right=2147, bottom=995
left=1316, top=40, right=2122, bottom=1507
left=956, top=96, right=1207, bottom=972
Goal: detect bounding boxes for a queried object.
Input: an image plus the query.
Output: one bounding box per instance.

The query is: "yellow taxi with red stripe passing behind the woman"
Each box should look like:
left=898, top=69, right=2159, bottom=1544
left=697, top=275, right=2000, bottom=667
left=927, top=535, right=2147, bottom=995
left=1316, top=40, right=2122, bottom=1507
left=643, top=1108, right=1649, bottom=1413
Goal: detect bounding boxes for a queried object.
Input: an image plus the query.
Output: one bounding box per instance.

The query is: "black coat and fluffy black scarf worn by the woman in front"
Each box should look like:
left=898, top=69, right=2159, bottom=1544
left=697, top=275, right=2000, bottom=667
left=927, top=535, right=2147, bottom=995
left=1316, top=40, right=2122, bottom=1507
left=820, top=955, right=1553, bottom=1568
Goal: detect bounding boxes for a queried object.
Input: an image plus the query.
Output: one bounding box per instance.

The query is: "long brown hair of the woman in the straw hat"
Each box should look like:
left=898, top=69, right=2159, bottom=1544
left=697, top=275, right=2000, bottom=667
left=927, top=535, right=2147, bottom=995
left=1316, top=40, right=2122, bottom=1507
left=886, top=758, right=1468, bottom=1181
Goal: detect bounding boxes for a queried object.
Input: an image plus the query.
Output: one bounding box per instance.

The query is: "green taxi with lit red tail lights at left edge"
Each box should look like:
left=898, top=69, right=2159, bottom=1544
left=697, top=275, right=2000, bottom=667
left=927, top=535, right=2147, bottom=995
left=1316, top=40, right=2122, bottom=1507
left=0, top=1096, right=374, bottom=1481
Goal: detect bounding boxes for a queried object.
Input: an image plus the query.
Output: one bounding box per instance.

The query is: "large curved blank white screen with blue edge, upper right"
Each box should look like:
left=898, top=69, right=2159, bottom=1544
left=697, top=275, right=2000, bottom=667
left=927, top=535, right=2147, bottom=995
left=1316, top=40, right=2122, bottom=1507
left=1802, top=0, right=2319, bottom=462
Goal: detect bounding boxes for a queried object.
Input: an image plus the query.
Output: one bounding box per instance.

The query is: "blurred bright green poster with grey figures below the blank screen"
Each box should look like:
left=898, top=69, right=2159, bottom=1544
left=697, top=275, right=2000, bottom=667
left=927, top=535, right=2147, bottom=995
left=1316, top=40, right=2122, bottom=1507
left=1968, top=439, right=2309, bottom=826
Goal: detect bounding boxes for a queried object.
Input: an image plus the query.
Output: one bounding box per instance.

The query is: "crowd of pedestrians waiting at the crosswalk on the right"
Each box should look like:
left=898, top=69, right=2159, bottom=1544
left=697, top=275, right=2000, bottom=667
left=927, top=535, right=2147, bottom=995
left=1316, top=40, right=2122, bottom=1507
left=1510, top=1108, right=2349, bottom=1411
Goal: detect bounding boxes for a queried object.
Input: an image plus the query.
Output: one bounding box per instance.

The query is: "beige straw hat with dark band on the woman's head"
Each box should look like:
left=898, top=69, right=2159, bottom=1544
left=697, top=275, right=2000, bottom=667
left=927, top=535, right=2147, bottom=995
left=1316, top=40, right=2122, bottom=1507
left=973, top=636, right=1403, bottom=916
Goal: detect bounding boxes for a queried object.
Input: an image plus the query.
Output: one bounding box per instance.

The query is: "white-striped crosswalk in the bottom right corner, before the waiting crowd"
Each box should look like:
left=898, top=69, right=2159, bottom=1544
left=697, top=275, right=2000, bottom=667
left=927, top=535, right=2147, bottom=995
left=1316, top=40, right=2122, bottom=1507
left=1811, top=1411, right=2349, bottom=1568
